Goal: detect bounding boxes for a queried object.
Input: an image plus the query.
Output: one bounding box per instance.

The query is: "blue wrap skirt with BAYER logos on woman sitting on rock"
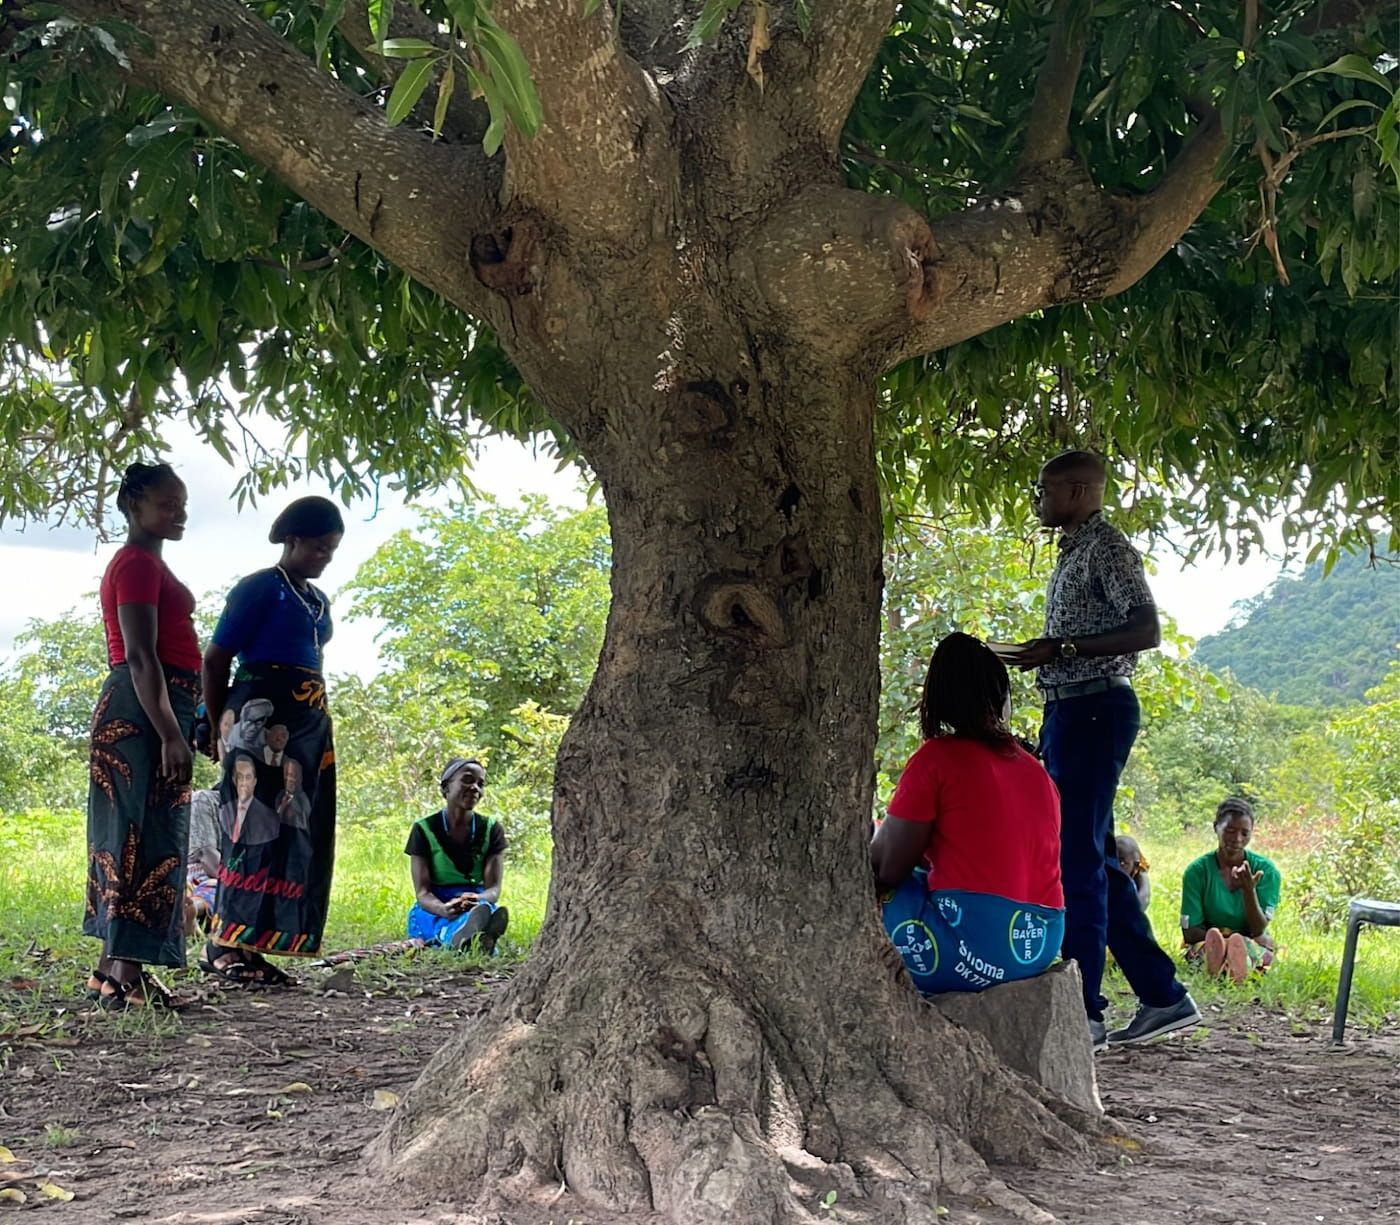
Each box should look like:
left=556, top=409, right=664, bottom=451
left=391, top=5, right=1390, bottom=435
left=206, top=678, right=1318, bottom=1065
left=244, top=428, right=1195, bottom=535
left=881, top=869, right=1064, bottom=995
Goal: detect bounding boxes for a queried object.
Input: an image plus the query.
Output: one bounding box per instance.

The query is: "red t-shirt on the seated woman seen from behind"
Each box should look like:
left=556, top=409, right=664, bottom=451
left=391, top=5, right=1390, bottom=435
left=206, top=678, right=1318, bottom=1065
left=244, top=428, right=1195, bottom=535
left=888, top=736, right=1064, bottom=909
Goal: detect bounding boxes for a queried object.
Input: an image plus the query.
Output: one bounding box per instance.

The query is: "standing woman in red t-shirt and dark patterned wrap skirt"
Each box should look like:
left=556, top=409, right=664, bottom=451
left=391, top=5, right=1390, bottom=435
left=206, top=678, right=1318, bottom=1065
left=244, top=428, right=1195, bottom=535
left=83, top=463, right=200, bottom=1009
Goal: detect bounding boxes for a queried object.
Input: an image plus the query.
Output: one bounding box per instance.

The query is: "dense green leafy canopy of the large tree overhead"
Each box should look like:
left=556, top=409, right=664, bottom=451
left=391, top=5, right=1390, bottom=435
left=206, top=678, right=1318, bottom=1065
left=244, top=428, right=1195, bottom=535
left=0, top=0, right=1400, bottom=547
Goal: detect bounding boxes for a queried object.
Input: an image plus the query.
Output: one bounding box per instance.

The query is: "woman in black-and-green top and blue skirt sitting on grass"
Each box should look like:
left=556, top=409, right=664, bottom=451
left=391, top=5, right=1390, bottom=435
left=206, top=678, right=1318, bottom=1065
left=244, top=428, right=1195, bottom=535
left=403, top=757, right=511, bottom=956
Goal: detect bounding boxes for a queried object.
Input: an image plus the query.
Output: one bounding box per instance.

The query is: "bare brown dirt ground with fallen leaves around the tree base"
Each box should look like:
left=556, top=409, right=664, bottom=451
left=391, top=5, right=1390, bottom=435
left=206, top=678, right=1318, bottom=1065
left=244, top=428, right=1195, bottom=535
left=0, top=963, right=1400, bottom=1225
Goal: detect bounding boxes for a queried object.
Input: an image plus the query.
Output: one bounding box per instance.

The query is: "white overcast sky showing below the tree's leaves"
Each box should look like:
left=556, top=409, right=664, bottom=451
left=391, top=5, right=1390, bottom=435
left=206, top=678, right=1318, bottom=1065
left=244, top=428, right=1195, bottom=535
left=0, top=430, right=1280, bottom=675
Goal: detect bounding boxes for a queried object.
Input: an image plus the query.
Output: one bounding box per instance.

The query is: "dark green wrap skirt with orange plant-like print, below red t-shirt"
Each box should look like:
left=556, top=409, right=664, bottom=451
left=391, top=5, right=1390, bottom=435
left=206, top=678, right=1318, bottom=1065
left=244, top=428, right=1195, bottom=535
left=83, top=664, right=199, bottom=966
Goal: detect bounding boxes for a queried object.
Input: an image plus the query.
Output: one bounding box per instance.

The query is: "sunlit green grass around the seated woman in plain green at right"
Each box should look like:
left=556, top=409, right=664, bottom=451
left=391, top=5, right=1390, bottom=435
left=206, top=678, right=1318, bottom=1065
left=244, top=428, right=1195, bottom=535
left=1110, top=830, right=1400, bottom=1026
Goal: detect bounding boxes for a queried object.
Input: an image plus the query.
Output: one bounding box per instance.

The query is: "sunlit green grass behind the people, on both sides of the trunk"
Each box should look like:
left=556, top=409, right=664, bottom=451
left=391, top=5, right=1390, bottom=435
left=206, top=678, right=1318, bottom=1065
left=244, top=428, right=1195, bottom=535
left=0, top=812, right=1400, bottom=1030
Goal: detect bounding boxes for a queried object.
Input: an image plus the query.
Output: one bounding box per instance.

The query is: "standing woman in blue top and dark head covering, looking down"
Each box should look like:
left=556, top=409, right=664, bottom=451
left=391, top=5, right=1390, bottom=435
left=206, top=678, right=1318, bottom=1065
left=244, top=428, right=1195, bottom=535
left=200, top=497, right=344, bottom=986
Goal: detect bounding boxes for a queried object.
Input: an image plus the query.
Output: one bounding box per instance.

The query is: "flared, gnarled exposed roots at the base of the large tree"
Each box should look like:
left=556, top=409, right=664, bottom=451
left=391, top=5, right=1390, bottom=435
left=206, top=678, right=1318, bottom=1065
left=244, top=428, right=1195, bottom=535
left=374, top=949, right=1088, bottom=1225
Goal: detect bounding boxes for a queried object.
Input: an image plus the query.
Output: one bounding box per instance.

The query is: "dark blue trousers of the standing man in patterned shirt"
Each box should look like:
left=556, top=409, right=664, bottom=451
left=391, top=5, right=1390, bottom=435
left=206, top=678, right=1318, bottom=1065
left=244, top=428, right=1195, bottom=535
left=1040, top=685, right=1186, bottom=1021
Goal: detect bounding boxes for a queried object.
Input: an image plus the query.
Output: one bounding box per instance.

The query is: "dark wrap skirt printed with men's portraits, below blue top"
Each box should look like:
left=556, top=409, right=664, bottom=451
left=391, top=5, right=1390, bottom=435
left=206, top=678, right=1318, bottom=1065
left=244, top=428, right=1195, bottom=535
left=210, top=664, right=336, bottom=958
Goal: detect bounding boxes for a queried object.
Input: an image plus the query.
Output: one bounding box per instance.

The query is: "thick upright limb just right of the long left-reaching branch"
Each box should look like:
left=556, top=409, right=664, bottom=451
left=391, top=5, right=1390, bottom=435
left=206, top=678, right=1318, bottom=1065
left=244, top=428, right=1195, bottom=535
left=493, top=0, right=679, bottom=242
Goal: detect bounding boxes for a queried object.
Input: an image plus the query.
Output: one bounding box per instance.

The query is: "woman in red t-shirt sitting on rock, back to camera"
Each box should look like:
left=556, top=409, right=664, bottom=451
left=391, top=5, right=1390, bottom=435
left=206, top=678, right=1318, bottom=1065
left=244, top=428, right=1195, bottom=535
left=871, top=634, right=1064, bottom=994
